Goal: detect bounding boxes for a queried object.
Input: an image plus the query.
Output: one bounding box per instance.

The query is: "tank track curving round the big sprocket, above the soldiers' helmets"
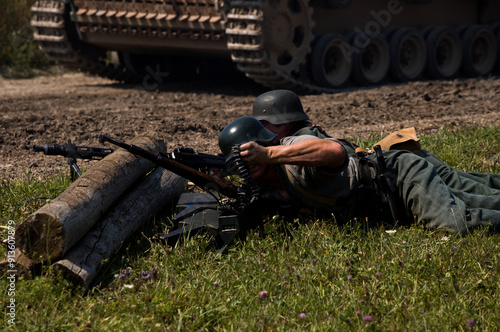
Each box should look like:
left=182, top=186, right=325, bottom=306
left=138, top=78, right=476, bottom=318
left=226, top=0, right=333, bottom=92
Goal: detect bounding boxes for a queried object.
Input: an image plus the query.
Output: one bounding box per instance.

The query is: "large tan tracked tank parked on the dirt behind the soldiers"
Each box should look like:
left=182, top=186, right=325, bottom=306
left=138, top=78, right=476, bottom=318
left=32, top=0, right=500, bottom=91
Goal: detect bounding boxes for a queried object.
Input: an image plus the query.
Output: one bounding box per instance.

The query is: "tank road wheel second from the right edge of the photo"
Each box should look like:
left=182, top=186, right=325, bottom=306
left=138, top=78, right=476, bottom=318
left=426, top=27, right=462, bottom=79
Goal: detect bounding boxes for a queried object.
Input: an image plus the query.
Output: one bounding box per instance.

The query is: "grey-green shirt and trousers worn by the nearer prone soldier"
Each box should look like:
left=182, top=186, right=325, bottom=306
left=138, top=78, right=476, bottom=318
left=276, top=135, right=500, bottom=233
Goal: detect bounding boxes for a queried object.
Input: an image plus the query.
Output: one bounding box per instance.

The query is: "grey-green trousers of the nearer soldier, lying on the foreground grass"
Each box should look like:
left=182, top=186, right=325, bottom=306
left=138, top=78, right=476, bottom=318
left=376, top=150, right=500, bottom=233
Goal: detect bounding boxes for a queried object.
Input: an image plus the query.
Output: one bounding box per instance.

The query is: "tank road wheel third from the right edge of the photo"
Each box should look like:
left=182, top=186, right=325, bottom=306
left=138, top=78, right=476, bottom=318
left=389, top=29, right=427, bottom=82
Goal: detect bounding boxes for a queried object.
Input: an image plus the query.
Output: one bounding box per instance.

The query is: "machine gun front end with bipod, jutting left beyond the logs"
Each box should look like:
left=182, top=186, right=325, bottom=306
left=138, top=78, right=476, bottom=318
left=33, top=140, right=113, bottom=181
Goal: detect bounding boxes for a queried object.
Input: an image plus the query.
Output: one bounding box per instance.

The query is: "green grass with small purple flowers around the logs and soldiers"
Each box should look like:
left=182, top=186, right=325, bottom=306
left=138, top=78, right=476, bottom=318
left=0, top=126, right=500, bottom=331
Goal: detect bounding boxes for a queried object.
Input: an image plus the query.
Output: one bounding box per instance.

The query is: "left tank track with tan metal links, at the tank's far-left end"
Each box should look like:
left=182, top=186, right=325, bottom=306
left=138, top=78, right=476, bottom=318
left=31, top=0, right=139, bottom=82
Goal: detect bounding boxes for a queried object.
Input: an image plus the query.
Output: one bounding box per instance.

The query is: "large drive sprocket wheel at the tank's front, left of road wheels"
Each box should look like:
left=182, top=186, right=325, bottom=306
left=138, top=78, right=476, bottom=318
left=263, top=0, right=314, bottom=76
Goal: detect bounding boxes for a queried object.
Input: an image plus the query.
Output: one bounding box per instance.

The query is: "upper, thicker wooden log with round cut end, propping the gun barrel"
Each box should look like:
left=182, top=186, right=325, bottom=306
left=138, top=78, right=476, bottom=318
left=16, top=132, right=166, bottom=263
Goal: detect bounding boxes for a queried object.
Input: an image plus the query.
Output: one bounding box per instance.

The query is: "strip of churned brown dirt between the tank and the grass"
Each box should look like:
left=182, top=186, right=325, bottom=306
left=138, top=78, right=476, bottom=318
left=0, top=73, right=500, bottom=179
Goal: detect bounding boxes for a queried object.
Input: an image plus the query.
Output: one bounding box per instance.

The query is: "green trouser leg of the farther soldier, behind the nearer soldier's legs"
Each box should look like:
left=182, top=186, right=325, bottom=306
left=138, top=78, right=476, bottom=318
left=420, top=150, right=500, bottom=195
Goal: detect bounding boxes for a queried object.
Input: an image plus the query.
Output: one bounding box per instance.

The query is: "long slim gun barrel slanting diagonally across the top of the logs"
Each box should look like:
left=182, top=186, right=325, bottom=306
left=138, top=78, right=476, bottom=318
left=99, top=134, right=239, bottom=198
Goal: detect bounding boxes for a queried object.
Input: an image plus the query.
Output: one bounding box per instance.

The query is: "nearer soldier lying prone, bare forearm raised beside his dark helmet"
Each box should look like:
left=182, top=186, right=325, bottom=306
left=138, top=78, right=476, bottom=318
left=219, top=117, right=500, bottom=233
